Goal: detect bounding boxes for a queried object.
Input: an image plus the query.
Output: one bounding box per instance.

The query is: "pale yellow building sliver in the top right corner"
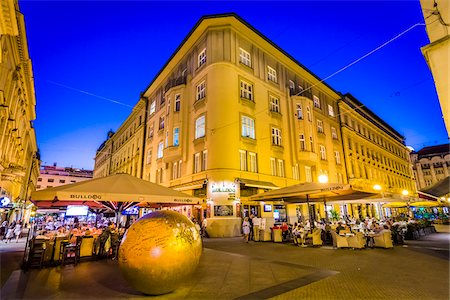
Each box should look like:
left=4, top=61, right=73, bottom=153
left=420, top=0, right=450, bottom=135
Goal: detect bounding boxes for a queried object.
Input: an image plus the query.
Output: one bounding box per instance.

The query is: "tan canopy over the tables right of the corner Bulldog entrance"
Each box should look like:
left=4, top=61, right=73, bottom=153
left=250, top=182, right=377, bottom=203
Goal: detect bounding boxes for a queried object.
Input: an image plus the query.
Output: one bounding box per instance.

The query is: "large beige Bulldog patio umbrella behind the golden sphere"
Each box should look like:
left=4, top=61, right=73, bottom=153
left=31, top=174, right=202, bottom=223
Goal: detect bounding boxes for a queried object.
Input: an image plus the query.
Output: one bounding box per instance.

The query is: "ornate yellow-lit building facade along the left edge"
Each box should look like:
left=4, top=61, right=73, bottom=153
left=0, top=0, right=40, bottom=220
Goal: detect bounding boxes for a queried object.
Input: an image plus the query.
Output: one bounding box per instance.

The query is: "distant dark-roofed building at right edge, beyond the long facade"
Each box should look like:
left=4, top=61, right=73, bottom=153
left=411, top=144, right=450, bottom=190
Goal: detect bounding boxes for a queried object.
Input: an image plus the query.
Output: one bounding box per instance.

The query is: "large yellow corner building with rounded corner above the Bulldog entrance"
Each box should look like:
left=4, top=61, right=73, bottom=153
left=96, top=14, right=416, bottom=236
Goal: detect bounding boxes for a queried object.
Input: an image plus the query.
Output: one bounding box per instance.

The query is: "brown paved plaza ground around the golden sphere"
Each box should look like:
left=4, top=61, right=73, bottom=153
left=0, top=226, right=450, bottom=299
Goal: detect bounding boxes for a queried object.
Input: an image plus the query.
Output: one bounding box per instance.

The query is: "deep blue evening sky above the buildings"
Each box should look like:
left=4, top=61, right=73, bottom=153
left=19, top=0, right=448, bottom=169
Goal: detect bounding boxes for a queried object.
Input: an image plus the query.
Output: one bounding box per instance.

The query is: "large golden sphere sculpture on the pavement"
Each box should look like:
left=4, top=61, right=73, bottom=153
left=119, top=210, right=202, bottom=295
